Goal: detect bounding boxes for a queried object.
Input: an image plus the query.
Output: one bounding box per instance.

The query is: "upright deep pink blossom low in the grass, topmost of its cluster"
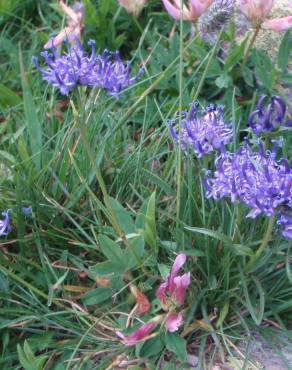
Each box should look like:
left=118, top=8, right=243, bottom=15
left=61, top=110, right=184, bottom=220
left=156, top=253, right=191, bottom=306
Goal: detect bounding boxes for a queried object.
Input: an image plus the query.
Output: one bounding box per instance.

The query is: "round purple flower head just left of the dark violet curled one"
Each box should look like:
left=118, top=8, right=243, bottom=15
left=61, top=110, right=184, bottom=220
left=169, top=103, right=233, bottom=158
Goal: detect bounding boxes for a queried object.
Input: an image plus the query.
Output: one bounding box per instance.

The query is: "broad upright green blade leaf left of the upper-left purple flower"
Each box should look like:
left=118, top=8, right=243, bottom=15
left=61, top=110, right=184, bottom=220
left=19, top=49, right=42, bottom=170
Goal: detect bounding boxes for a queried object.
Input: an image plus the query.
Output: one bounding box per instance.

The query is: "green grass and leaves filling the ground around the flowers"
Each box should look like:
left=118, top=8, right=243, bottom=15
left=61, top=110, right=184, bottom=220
left=0, top=1, right=292, bottom=370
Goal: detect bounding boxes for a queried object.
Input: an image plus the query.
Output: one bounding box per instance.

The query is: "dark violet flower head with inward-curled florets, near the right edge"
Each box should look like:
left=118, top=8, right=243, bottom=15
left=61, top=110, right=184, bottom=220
left=248, top=95, right=292, bottom=135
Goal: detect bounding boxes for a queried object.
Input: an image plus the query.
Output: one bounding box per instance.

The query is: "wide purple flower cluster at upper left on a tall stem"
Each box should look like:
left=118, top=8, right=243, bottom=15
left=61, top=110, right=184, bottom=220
left=33, top=40, right=140, bottom=96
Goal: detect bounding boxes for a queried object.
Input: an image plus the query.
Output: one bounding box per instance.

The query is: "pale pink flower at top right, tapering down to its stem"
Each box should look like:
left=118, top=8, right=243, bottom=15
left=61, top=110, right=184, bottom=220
left=240, top=0, right=275, bottom=27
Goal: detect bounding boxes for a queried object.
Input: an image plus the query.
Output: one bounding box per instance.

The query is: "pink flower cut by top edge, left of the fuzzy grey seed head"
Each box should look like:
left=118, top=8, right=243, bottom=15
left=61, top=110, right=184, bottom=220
left=162, top=0, right=214, bottom=22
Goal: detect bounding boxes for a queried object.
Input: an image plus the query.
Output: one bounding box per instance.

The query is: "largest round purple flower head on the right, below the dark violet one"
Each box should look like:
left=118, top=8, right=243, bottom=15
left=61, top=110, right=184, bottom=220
left=206, top=145, right=292, bottom=218
